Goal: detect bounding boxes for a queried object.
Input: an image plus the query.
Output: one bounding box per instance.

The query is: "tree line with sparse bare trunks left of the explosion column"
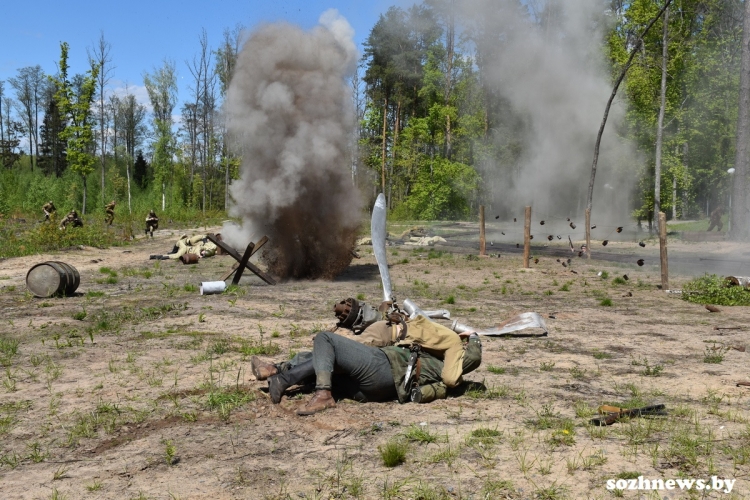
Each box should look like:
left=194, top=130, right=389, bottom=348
left=0, top=26, right=241, bottom=219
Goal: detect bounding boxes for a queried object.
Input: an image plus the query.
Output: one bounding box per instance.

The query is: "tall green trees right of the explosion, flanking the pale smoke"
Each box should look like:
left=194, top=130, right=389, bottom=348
left=354, top=0, right=745, bottom=229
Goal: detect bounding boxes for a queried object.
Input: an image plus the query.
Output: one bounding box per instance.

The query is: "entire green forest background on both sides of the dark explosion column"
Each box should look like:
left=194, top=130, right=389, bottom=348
left=0, top=0, right=745, bottom=236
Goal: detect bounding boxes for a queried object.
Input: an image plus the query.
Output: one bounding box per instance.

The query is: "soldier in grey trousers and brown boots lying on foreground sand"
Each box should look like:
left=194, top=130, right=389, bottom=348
left=253, top=316, right=482, bottom=415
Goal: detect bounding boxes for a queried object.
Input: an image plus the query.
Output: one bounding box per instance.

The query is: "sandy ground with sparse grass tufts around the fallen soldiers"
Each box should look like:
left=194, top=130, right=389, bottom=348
left=0, top=231, right=750, bottom=499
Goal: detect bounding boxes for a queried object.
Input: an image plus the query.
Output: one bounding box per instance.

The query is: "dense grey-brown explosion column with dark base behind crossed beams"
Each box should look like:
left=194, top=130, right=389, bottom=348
left=222, top=10, right=361, bottom=279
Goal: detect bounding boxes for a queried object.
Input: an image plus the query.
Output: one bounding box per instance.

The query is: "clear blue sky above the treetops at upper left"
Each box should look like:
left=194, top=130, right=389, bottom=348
left=0, top=0, right=402, bottom=111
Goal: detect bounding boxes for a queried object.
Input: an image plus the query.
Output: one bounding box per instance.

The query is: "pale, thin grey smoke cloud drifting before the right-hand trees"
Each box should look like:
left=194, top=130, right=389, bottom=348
left=468, top=0, right=640, bottom=223
